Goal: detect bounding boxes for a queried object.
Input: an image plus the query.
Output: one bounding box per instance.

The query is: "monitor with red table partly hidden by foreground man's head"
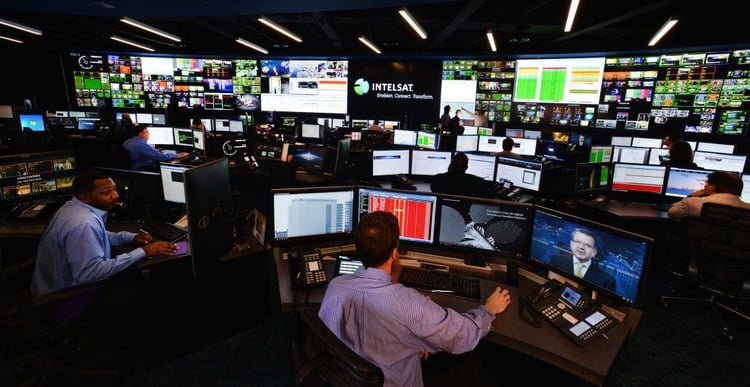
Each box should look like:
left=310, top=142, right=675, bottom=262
left=356, top=187, right=437, bottom=245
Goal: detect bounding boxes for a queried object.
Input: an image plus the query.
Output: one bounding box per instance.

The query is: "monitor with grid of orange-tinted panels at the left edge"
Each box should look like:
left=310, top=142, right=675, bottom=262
left=0, top=150, right=78, bottom=204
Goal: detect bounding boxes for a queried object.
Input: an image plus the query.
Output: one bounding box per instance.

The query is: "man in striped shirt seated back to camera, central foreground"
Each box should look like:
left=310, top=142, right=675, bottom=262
left=319, top=211, right=510, bottom=387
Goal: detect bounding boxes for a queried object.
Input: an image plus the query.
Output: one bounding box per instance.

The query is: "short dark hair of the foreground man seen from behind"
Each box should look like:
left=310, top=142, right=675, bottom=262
left=354, top=211, right=399, bottom=267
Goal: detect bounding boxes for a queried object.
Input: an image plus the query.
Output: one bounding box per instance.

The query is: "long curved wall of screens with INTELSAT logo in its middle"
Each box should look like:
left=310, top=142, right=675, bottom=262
left=67, top=49, right=750, bottom=136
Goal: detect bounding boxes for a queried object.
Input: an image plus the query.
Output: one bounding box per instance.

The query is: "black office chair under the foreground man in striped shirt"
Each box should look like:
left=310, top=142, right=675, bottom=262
left=292, top=307, right=384, bottom=387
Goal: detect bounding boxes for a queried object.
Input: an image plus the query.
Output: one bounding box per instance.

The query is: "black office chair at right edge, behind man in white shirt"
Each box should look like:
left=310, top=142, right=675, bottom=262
left=661, top=203, right=750, bottom=343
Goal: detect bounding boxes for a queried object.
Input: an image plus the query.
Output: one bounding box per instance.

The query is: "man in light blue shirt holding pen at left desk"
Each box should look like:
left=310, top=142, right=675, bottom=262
left=31, top=170, right=182, bottom=296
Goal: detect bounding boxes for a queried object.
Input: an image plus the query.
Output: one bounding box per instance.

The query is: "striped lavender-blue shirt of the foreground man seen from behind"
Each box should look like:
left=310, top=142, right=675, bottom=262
left=319, top=267, right=495, bottom=386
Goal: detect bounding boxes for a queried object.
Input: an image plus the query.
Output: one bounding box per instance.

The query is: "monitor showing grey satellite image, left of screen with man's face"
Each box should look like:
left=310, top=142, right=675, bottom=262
left=438, top=195, right=534, bottom=266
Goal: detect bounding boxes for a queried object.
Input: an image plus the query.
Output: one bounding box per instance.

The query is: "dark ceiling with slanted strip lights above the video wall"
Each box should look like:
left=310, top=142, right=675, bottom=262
left=0, top=0, right=750, bottom=58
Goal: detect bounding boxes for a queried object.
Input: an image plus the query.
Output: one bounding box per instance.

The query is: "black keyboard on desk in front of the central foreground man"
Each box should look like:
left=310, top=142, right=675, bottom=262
left=399, top=266, right=480, bottom=301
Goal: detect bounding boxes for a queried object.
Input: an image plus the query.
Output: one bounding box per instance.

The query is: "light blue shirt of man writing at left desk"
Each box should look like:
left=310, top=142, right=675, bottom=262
left=31, top=198, right=146, bottom=296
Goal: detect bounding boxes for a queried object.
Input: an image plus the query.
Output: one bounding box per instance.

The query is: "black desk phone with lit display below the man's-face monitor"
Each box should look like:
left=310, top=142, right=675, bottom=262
left=524, top=279, right=617, bottom=346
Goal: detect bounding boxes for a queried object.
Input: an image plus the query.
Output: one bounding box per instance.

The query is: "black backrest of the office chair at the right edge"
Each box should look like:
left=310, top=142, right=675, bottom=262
left=683, top=203, right=750, bottom=297
